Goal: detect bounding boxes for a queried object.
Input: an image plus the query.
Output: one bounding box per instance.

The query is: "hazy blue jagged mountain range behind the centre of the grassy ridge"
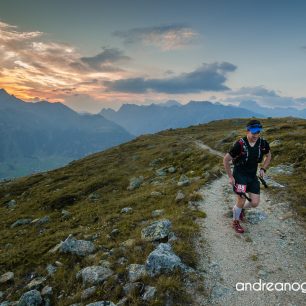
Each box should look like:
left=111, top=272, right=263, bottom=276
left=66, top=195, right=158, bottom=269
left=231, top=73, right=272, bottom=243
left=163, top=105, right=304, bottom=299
left=100, top=101, right=265, bottom=135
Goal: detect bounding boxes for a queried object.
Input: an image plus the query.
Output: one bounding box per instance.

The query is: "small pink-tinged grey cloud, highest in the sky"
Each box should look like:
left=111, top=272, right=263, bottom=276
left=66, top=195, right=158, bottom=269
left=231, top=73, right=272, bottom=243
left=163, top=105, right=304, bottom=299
left=113, top=24, right=198, bottom=51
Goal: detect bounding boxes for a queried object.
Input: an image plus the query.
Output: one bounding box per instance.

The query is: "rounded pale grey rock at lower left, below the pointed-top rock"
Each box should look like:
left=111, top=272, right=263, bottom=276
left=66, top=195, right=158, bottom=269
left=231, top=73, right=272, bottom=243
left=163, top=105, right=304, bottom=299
left=76, top=266, right=113, bottom=285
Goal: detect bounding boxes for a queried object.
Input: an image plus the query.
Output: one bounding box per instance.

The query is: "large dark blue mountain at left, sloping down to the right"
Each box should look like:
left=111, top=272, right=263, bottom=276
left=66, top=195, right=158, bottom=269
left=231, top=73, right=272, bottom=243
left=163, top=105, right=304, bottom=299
left=0, top=90, right=133, bottom=178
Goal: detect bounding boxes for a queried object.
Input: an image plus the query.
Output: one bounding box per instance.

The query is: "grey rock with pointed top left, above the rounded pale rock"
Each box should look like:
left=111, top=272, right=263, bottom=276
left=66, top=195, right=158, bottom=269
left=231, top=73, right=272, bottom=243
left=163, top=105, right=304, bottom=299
left=59, top=235, right=95, bottom=256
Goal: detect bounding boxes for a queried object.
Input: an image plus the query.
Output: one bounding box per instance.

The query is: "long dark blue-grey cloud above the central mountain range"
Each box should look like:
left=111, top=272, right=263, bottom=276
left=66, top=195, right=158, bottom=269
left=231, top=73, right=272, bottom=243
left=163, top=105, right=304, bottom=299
left=104, top=62, right=236, bottom=94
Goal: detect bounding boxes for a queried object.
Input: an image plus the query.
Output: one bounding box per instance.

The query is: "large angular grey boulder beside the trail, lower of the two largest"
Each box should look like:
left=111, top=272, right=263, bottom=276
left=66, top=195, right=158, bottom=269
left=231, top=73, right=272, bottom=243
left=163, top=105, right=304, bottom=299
left=145, top=243, right=190, bottom=277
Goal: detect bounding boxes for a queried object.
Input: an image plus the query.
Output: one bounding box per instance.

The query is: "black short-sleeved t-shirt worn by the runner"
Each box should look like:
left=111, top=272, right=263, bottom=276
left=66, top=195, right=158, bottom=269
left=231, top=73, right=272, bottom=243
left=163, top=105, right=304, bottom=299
left=229, top=137, right=270, bottom=175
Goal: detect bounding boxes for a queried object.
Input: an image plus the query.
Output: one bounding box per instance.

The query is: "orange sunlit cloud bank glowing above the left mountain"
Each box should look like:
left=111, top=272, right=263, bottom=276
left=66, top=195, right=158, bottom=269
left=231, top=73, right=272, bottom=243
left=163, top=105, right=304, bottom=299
left=0, top=21, right=130, bottom=101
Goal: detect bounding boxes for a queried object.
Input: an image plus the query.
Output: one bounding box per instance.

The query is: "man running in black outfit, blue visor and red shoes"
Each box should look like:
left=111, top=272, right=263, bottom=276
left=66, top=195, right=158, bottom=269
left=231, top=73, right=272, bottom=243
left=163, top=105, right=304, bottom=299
left=223, top=120, right=271, bottom=233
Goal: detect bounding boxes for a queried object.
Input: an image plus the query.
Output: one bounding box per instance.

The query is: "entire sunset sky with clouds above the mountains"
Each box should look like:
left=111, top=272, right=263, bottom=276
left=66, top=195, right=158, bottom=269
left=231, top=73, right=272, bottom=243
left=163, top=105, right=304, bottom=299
left=0, top=0, right=306, bottom=112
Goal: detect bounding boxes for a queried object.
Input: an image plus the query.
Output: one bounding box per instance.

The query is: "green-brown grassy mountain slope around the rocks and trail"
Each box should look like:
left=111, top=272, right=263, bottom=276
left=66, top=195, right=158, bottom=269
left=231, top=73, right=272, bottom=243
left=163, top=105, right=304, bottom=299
left=0, top=118, right=306, bottom=305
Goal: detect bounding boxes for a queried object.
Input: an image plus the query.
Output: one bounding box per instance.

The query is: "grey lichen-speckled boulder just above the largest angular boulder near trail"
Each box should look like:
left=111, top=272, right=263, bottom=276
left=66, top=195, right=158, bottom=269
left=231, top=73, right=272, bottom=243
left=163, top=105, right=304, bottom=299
left=141, top=219, right=171, bottom=241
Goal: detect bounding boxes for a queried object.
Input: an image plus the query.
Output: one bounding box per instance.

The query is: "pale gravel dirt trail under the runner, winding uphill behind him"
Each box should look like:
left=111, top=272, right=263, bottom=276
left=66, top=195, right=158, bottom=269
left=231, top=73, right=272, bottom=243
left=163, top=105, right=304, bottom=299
left=194, top=141, right=306, bottom=306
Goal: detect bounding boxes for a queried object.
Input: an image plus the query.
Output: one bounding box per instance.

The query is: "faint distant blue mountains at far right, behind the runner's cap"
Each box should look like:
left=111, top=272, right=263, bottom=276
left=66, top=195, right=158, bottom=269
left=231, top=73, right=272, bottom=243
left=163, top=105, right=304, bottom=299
left=239, top=100, right=306, bottom=119
